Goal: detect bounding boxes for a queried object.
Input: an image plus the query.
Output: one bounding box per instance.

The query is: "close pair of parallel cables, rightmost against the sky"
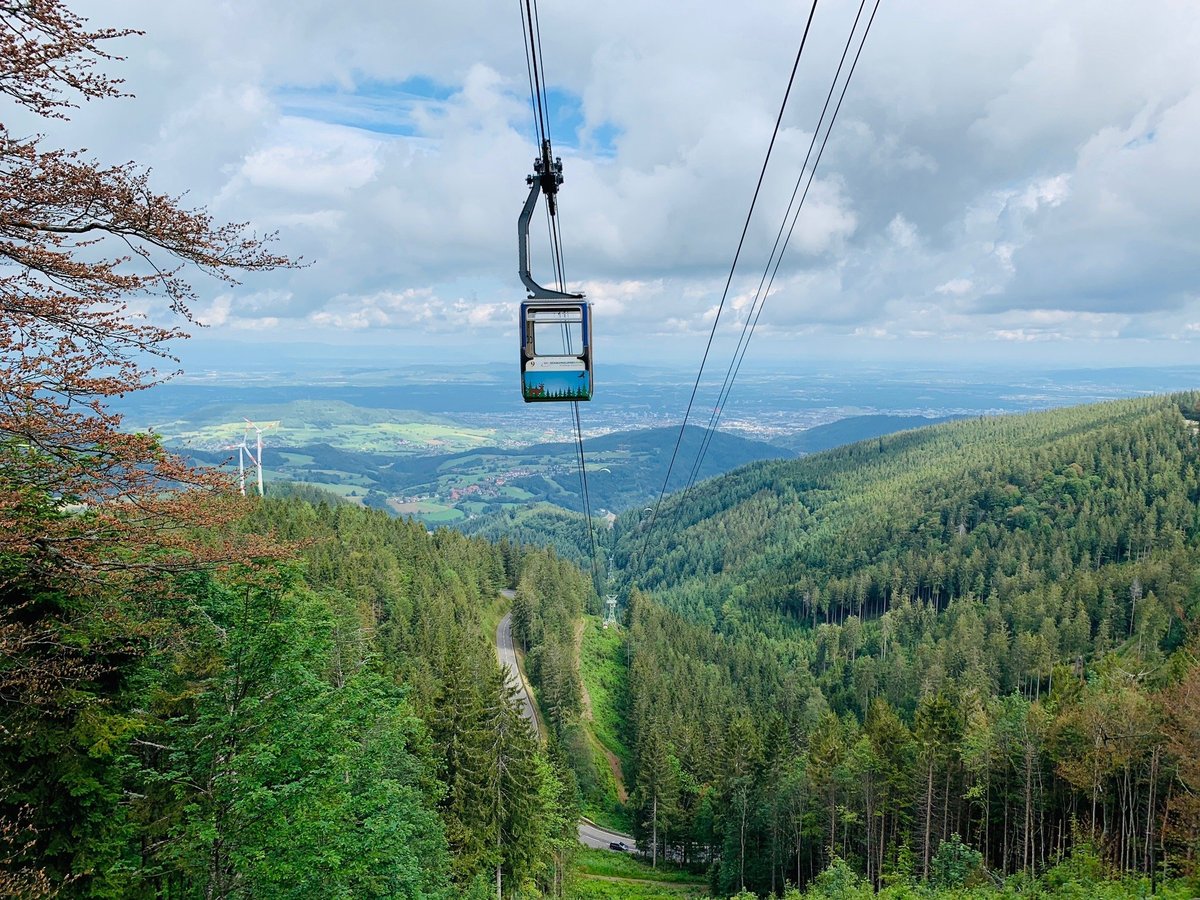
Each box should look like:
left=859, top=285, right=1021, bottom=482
left=680, top=0, right=878, bottom=503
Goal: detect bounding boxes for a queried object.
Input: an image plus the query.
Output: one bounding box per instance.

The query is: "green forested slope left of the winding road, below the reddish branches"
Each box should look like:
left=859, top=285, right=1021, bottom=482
left=0, top=498, right=587, bottom=898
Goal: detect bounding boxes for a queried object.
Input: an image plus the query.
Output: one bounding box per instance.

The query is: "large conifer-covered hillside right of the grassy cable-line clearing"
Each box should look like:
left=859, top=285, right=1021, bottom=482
left=616, top=394, right=1200, bottom=889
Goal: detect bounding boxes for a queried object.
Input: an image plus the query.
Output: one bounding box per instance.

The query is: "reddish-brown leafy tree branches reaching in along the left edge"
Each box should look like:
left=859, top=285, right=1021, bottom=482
left=0, top=0, right=293, bottom=574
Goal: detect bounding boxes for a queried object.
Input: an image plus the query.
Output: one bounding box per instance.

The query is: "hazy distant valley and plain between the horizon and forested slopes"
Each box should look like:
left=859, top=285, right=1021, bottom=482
left=116, top=366, right=1200, bottom=533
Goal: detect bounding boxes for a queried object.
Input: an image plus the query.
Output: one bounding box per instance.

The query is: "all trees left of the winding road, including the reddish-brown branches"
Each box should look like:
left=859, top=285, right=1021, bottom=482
left=0, top=7, right=576, bottom=898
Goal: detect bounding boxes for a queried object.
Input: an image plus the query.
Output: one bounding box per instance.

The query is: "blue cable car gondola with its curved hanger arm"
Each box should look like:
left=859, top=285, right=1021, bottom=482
left=517, top=140, right=592, bottom=403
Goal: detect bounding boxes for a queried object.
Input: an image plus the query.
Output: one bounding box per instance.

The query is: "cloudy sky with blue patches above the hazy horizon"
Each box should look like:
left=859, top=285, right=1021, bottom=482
left=16, top=0, right=1200, bottom=366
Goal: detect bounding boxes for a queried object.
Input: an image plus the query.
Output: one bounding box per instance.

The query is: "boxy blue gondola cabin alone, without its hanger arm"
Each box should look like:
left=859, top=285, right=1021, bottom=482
left=521, top=300, right=592, bottom=403
